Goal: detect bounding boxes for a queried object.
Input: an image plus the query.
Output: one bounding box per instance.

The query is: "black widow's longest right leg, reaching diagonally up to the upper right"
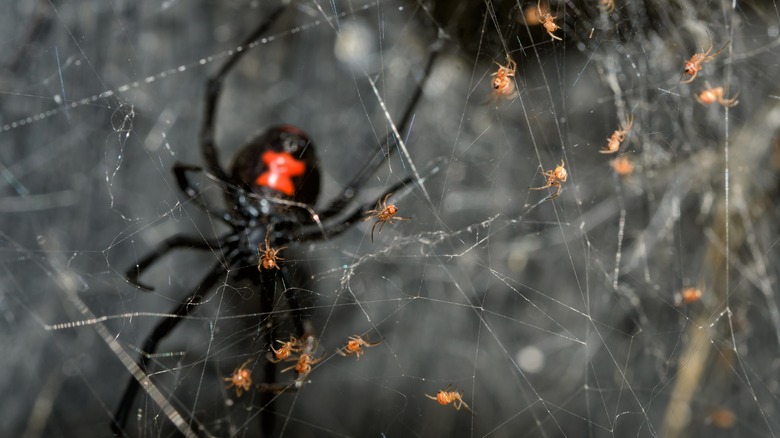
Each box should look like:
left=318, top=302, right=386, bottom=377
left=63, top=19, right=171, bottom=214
left=320, top=47, right=439, bottom=221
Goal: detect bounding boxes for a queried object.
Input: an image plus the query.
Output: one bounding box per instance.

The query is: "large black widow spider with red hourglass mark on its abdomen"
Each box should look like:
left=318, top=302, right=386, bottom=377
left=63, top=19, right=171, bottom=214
left=111, top=6, right=438, bottom=435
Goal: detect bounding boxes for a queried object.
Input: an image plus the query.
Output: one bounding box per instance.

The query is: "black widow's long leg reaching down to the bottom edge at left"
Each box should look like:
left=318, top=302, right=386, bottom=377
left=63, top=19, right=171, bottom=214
left=111, top=257, right=232, bottom=435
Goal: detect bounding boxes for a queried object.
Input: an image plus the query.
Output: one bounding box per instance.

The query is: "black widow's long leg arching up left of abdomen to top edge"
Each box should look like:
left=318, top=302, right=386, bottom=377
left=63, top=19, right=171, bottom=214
left=199, top=6, right=287, bottom=181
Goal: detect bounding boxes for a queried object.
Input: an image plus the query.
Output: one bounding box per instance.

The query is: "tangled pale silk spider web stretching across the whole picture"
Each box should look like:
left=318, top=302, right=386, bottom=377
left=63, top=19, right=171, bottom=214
left=0, top=0, right=780, bottom=437
